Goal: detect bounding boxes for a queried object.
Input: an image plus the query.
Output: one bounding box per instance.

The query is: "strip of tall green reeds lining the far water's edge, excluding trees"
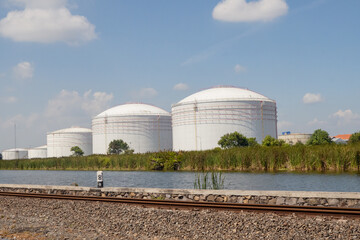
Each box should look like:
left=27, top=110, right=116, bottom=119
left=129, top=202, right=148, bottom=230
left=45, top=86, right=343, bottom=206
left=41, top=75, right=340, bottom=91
left=0, top=144, right=360, bottom=172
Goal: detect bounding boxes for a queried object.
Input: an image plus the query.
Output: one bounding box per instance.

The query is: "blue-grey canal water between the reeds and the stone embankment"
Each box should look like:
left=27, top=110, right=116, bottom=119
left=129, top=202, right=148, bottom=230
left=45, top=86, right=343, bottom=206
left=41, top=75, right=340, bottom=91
left=0, top=170, right=360, bottom=192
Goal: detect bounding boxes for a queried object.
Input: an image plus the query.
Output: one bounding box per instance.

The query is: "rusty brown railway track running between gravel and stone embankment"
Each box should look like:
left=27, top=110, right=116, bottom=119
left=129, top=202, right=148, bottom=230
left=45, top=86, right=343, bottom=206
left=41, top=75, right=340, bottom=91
left=0, top=192, right=360, bottom=218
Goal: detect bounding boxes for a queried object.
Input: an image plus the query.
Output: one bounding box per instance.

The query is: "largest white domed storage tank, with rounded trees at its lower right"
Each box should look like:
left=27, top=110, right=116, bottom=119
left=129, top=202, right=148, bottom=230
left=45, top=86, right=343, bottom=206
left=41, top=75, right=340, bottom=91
left=172, top=86, right=277, bottom=151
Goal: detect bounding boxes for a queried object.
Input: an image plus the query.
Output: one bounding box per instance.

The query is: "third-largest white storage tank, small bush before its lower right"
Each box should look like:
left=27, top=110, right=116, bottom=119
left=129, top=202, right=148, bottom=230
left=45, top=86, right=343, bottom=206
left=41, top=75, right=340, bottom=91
left=47, top=127, right=92, bottom=158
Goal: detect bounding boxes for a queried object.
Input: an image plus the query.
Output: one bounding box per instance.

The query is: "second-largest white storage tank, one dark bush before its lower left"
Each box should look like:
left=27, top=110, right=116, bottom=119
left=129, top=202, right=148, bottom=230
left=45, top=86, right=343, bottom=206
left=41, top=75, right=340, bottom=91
left=92, top=103, right=172, bottom=154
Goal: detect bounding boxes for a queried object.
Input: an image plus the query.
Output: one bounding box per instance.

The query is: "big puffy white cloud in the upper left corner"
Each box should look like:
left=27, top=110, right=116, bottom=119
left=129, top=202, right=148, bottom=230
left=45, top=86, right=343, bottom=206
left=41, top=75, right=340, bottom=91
left=0, top=0, right=96, bottom=44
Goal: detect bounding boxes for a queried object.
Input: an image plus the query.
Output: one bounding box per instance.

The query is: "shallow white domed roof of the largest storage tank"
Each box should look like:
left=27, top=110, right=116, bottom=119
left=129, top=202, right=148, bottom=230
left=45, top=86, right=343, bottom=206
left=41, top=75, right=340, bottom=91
left=179, top=86, right=274, bottom=104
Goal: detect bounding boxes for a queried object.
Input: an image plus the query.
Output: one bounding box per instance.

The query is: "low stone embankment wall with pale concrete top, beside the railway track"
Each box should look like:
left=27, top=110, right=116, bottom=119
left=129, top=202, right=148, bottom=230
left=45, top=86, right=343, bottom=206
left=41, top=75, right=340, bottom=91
left=0, top=184, right=360, bottom=208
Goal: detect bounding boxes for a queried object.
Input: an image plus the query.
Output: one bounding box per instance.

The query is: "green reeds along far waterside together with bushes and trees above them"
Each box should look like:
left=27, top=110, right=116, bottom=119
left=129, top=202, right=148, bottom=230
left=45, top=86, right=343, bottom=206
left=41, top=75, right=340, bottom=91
left=0, top=129, right=360, bottom=172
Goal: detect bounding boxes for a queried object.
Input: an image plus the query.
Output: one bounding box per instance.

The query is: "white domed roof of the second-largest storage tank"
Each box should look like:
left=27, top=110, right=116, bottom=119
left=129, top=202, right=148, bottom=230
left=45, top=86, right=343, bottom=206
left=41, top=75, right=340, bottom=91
left=95, top=103, right=170, bottom=118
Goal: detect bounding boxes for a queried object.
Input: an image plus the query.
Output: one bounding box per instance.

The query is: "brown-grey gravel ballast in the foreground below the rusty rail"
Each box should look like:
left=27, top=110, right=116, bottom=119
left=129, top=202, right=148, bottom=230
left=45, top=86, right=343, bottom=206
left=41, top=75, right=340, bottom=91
left=0, top=196, right=360, bottom=239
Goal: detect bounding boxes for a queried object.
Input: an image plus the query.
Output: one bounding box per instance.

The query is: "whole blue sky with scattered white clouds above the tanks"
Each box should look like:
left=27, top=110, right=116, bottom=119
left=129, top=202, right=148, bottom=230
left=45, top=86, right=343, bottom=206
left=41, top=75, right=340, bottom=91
left=0, top=0, right=360, bottom=151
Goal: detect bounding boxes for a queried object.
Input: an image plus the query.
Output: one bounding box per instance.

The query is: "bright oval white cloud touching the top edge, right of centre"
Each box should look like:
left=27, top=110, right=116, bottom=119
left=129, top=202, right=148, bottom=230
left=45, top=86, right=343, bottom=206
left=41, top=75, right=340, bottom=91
left=212, top=0, right=288, bottom=22
